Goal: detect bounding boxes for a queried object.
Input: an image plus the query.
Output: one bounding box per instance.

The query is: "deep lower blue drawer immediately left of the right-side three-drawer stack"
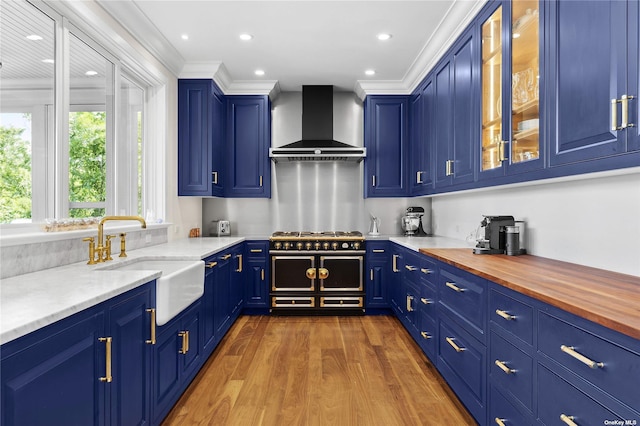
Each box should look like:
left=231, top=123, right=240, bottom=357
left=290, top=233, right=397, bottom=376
left=438, top=315, right=487, bottom=423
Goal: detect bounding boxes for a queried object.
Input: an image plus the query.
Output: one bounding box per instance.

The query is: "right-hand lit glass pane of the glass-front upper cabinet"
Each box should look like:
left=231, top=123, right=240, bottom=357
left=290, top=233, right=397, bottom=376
left=511, top=0, right=540, bottom=164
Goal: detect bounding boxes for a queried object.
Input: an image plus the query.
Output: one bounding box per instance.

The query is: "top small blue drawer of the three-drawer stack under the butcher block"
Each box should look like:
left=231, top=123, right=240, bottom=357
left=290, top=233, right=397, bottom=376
left=489, top=289, right=534, bottom=345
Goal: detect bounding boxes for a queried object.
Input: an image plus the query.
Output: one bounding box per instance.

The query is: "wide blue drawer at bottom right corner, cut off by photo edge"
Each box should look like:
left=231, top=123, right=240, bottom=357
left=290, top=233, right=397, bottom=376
left=538, top=365, right=630, bottom=426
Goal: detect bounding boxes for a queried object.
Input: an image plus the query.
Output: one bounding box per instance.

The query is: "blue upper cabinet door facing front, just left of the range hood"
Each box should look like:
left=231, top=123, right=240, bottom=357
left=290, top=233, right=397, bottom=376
left=225, top=96, right=271, bottom=198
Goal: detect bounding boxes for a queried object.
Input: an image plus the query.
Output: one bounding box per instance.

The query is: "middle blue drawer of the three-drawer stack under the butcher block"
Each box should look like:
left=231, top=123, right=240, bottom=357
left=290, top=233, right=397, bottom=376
left=489, top=332, right=533, bottom=410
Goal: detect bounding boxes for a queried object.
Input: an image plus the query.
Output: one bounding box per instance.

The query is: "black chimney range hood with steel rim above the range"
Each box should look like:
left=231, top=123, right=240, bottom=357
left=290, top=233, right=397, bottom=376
left=269, top=86, right=367, bottom=163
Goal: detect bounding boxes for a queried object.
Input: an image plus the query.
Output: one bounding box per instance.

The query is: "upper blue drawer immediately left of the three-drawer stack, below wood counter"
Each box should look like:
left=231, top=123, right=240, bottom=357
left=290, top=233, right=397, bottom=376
left=438, top=266, right=487, bottom=341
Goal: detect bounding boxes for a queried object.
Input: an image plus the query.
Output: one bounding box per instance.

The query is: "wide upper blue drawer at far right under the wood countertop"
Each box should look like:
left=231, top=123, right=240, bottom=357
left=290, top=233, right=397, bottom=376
left=538, top=312, right=640, bottom=412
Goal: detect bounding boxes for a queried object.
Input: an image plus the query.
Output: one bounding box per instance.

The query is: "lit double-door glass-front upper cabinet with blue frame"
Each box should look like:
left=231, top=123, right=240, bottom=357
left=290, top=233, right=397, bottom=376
left=480, top=0, right=542, bottom=179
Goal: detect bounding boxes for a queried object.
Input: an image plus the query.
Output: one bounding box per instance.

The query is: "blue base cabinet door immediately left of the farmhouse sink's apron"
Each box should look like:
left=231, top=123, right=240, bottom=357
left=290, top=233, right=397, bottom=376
left=107, top=286, right=152, bottom=425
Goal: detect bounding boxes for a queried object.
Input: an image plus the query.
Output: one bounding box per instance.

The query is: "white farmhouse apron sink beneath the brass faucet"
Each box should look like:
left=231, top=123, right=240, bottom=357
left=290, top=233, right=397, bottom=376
left=102, top=259, right=204, bottom=325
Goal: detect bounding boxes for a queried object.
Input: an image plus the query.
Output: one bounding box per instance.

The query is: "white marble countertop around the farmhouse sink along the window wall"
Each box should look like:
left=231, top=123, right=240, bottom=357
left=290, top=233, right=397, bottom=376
left=0, top=237, right=245, bottom=344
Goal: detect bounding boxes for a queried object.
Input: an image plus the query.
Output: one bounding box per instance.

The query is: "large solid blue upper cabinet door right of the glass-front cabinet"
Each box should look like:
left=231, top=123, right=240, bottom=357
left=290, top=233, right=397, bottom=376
left=545, top=1, right=627, bottom=166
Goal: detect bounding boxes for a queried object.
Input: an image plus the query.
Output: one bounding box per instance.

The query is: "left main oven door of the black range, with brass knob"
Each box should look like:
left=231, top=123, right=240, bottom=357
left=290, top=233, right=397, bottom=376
left=271, top=255, right=318, bottom=292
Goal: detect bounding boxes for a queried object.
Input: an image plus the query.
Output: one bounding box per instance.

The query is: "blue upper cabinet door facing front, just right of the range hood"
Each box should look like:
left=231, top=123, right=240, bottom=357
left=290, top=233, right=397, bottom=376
left=364, top=96, right=409, bottom=197
